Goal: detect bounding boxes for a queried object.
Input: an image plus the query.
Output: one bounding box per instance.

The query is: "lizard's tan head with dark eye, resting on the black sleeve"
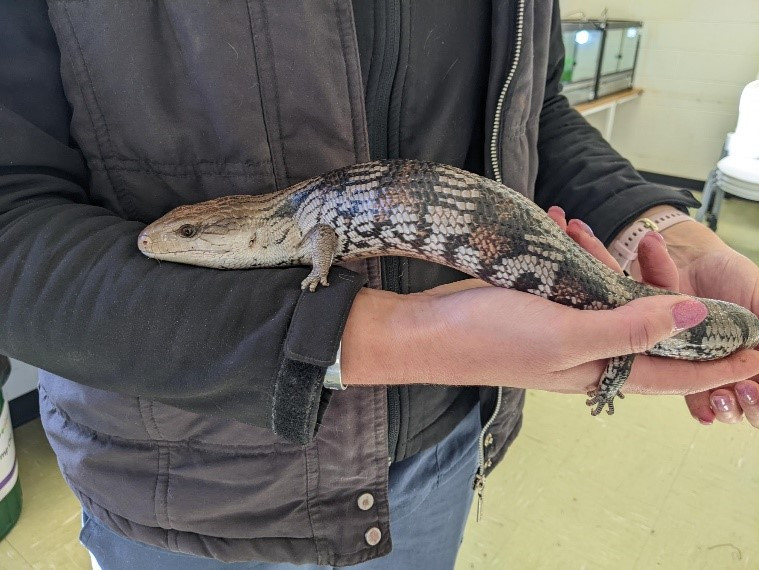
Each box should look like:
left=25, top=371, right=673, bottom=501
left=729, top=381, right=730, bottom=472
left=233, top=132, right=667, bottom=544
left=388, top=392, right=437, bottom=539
left=137, top=196, right=301, bottom=269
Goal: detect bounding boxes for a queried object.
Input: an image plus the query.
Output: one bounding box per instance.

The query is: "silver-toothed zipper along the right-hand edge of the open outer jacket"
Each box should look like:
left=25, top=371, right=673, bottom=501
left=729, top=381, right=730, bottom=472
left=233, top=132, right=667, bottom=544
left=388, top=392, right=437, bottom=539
left=474, top=0, right=525, bottom=522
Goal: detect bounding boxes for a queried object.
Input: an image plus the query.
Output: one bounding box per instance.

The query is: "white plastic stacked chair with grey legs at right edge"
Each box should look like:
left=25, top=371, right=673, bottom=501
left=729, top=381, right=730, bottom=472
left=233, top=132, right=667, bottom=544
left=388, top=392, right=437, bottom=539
left=696, top=80, right=759, bottom=230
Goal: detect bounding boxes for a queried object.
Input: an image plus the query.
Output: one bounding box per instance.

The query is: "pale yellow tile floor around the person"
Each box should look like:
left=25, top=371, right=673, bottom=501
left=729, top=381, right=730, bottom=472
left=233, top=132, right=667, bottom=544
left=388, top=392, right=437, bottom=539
left=0, top=194, right=759, bottom=570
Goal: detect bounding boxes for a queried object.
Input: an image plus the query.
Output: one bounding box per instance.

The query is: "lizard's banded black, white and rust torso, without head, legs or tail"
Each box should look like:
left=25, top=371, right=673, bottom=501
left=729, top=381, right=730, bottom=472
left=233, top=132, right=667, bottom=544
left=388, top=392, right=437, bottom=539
left=308, top=161, right=634, bottom=309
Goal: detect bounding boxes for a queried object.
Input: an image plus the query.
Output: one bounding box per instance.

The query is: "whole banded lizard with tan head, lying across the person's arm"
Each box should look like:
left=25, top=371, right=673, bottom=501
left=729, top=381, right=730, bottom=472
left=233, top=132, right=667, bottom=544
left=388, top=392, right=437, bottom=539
left=138, top=160, right=759, bottom=414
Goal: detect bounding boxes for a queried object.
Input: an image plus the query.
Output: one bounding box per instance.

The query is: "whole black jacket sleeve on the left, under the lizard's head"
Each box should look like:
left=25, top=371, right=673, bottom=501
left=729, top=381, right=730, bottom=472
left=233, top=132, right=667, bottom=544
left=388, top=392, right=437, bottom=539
left=0, top=0, right=363, bottom=443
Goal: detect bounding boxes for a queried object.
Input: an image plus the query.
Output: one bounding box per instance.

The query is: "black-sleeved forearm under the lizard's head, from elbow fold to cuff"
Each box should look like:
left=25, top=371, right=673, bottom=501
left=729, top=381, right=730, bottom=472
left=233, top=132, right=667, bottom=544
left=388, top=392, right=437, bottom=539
left=0, top=184, right=362, bottom=440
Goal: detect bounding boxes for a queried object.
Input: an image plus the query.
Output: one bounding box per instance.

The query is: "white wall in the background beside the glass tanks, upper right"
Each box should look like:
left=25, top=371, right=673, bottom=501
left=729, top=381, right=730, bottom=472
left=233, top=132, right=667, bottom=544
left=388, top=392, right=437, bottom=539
left=561, top=0, right=759, bottom=180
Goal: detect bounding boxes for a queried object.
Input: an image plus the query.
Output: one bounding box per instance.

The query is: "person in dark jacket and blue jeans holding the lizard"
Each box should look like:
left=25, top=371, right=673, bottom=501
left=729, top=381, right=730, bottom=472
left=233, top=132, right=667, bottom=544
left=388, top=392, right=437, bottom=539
left=0, top=0, right=759, bottom=570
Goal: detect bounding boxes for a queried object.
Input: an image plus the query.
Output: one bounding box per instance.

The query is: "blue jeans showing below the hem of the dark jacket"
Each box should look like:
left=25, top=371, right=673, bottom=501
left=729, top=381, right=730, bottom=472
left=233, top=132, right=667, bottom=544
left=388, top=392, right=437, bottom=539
left=79, top=404, right=481, bottom=570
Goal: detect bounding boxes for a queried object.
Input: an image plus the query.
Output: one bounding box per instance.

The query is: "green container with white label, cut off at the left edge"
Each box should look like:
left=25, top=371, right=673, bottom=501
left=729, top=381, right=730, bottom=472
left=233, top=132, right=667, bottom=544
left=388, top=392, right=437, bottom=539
left=0, top=355, right=21, bottom=540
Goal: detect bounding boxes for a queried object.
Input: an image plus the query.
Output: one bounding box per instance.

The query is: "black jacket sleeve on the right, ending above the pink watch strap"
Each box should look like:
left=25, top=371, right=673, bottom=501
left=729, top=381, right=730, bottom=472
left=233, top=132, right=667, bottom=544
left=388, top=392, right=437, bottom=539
left=535, top=1, right=699, bottom=245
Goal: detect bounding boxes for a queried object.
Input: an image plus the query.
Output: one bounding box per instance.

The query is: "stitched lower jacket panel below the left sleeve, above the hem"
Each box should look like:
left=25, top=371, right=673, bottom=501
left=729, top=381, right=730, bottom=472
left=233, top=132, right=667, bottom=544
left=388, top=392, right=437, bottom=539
left=40, top=373, right=313, bottom=539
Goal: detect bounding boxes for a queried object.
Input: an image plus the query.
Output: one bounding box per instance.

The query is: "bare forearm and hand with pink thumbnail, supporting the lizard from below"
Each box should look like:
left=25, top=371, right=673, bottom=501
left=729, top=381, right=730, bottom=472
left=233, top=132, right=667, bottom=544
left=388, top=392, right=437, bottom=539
left=342, top=246, right=759, bottom=394
